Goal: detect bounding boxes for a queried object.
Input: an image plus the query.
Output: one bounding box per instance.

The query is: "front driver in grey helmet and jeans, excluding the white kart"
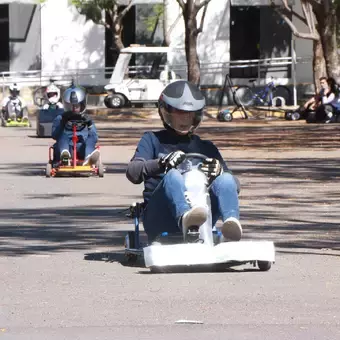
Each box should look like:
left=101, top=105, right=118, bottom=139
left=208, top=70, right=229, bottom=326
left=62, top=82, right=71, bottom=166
left=126, top=80, right=242, bottom=242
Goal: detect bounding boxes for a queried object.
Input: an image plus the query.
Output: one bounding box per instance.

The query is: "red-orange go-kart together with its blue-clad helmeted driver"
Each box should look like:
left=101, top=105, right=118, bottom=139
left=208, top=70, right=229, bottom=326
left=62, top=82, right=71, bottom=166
left=46, top=86, right=104, bottom=177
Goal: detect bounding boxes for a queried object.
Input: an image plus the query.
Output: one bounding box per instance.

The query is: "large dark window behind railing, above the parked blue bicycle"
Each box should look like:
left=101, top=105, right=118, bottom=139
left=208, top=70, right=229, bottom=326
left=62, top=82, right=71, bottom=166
left=230, top=5, right=292, bottom=78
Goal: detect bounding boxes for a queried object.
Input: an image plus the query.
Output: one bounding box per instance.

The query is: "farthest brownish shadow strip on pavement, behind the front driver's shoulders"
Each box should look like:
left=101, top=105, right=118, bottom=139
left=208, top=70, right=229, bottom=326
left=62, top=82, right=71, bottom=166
left=94, top=120, right=340, bottom=151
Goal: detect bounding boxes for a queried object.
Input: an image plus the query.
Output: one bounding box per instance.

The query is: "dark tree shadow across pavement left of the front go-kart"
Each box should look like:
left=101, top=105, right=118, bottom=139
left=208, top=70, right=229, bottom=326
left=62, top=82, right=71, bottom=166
left=0, top=206, right=131, bottom=256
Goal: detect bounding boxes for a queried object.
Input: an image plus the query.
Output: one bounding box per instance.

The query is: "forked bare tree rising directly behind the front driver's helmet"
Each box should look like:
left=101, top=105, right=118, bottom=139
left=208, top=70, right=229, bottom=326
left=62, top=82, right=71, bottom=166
left=176, top=0, right=211, bottom=85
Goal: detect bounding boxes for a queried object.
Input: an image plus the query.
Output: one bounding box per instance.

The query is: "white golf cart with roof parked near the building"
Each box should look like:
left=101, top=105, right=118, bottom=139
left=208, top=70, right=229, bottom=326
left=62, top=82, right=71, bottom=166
left=104, top=46, right=176, bottom=108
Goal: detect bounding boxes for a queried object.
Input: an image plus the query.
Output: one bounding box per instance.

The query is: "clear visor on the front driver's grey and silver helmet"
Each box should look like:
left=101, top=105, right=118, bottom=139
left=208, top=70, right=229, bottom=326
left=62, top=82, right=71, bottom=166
left=160, top=105, right=203, bottom=134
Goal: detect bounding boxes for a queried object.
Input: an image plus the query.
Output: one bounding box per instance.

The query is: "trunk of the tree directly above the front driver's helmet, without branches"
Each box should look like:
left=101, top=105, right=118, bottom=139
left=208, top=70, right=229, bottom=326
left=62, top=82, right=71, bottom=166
left=183, top=5, right=201, bottom=85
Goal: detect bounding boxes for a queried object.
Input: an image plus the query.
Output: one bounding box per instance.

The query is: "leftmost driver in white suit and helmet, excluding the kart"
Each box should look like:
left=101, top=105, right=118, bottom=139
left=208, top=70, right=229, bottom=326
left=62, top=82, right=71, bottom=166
left=1, top=83, right=28, bottom=122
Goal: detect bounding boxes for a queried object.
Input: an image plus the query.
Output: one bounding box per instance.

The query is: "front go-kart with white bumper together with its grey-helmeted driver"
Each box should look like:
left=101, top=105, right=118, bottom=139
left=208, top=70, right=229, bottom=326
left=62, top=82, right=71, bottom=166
left=125, top=81, right=275, bottom=270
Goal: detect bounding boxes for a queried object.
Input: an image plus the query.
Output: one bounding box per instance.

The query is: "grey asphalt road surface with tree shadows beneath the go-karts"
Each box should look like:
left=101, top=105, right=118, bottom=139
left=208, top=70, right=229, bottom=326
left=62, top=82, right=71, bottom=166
left=0, top=117, right=340, bottom=340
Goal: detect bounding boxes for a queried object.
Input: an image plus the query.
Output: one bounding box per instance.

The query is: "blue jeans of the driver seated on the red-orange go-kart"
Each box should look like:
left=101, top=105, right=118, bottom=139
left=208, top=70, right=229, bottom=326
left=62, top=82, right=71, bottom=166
left=55, top=132, right=98, bottom=161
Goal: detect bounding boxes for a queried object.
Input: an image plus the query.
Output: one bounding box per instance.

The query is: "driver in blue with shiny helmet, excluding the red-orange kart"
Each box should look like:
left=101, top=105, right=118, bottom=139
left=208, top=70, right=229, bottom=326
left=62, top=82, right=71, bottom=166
left=52, top=86, right=100, bottom=165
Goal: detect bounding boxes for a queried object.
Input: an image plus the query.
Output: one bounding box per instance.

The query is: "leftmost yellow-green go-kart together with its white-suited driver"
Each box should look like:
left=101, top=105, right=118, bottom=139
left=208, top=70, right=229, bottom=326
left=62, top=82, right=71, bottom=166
left=1, top=83, right=31, bottom=127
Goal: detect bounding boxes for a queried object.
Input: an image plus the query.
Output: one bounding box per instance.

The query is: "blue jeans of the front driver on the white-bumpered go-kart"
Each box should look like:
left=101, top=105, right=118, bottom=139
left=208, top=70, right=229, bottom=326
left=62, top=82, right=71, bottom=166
left=143, top=169, right=239, bottom=242
